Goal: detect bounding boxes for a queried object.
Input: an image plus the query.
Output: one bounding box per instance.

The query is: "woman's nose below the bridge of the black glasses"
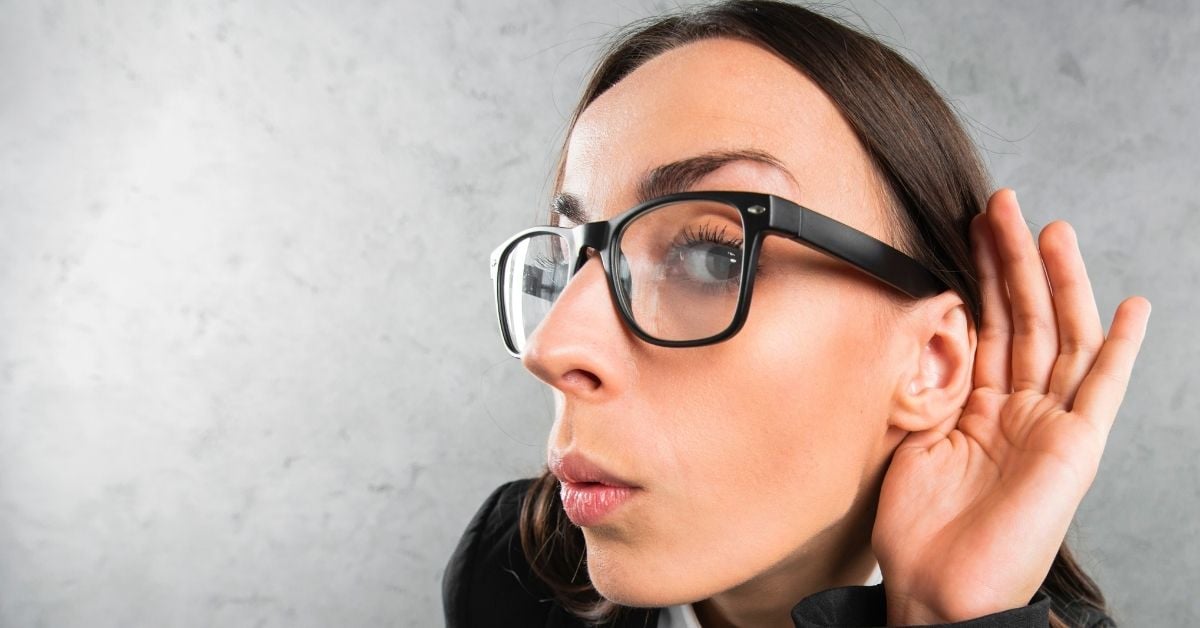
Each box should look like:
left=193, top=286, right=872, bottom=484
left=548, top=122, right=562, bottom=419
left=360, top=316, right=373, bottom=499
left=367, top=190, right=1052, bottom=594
left=521, top=251, right=637, bottom=400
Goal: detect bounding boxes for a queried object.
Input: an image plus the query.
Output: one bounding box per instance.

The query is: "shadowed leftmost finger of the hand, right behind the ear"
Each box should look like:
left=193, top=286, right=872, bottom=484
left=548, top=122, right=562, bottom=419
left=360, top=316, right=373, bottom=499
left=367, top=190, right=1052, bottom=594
left=971, top=214, right=1013, bottom=393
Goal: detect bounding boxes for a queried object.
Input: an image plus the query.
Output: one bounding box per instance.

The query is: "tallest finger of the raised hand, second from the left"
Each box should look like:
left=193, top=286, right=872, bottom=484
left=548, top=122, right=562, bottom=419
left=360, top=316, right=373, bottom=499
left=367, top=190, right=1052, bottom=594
left=986, top=190, right=1058, bottom=393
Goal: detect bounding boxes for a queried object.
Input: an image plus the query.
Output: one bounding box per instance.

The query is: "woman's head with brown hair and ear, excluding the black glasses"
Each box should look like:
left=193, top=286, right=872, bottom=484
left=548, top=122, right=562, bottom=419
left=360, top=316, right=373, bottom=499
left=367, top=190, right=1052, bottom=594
left=522, top=2, right=1104, bottom=616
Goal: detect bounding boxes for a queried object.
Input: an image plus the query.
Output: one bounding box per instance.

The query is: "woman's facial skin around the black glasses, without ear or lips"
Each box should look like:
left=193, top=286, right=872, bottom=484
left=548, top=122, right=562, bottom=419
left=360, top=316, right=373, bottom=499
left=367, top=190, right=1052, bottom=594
left=523, top=40, right=902, bottom=605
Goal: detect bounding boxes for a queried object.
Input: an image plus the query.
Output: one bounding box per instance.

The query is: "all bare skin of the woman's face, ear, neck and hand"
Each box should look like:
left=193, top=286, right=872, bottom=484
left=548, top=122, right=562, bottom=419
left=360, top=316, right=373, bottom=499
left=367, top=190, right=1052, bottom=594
left=522, top=40, right=1150, bottom=627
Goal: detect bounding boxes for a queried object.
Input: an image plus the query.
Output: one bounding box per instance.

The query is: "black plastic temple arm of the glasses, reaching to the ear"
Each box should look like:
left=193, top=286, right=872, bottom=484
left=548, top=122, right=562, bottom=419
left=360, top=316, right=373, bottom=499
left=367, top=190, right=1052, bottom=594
left=770, top=197, right=947, bottom=298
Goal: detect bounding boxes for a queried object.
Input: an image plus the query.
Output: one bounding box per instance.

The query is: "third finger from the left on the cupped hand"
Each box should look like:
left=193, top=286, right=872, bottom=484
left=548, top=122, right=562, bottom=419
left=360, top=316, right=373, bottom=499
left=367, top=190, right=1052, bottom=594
left=1038, top=220, right=1104, bottom=408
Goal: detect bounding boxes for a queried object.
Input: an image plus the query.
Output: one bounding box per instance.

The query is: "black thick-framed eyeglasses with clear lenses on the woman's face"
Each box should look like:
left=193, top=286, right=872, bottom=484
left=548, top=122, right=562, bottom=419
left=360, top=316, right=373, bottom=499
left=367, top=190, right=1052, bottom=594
left=491, top=192, right=946, bottom=358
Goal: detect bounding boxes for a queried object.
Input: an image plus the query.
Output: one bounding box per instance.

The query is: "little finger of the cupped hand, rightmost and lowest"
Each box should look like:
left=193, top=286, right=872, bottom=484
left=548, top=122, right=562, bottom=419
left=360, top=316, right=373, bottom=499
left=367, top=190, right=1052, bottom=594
left=1072, top=297, right=1150, bottom=435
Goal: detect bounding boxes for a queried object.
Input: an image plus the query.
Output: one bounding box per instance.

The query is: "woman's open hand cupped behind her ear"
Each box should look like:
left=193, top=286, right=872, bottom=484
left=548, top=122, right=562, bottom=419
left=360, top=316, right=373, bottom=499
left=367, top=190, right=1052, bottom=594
left=872, top=190, right=1150, bottom=624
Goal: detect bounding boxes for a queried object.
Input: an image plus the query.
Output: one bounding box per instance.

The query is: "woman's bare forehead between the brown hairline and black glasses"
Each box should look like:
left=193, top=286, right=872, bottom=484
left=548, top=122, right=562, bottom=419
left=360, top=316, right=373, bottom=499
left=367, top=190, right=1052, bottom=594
left=563, top=38, right=880, bottom=234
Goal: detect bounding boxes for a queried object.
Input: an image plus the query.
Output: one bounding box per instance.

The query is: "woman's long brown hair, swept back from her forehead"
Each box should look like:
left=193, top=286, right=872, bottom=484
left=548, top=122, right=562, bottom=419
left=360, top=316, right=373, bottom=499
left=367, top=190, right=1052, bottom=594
left=520, top=0, right=1106, bottom=627
